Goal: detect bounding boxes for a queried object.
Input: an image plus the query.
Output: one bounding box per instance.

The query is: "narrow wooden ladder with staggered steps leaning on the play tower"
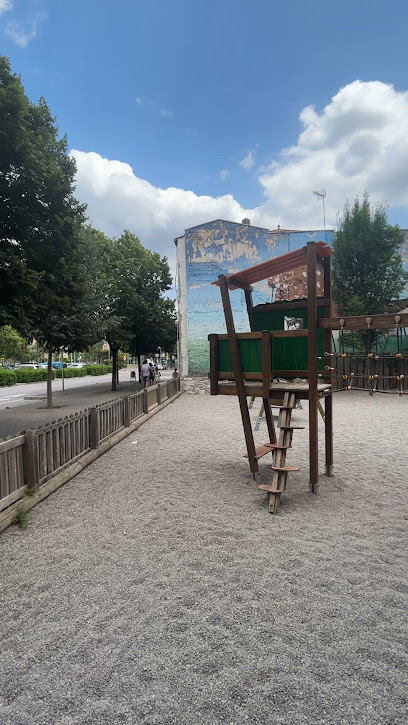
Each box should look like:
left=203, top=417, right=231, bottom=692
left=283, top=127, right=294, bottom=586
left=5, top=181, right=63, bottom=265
left=258, top=393, right=304, bottom=514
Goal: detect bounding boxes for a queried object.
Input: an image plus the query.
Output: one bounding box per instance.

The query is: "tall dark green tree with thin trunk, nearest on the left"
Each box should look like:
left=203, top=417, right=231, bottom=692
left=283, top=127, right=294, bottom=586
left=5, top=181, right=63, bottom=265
left=0, top=57, right=95, bottom=407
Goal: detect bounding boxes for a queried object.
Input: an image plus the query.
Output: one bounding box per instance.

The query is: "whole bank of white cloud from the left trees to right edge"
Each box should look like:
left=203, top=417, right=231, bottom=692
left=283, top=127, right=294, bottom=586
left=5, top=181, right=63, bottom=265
left=72, top=81, right=408, bottom=266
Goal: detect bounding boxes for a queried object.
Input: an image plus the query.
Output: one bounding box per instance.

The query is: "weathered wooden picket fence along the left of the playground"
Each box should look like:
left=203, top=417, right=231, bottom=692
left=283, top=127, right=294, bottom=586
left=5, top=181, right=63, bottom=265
left=0, top=379, right=180, bottom=511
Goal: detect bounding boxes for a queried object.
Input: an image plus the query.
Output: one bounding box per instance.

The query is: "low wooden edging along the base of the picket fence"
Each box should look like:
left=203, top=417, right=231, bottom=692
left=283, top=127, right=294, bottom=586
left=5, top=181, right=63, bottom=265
left=0, top=390, right=183, bottom=533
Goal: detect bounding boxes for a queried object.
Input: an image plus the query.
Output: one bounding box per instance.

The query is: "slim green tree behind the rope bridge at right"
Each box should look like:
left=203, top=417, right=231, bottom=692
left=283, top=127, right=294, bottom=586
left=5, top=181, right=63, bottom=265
left=332, top=192, right=408, bottom=315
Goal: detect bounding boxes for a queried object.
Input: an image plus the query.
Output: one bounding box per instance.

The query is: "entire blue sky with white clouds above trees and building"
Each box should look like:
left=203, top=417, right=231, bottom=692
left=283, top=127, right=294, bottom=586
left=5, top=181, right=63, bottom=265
left=0, top=0, right=408, bottom=253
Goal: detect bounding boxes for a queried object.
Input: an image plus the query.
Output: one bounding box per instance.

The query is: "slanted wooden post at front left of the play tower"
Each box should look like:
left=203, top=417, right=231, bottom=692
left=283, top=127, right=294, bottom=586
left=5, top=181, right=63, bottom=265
left=218, top=274, right=259, bottom=481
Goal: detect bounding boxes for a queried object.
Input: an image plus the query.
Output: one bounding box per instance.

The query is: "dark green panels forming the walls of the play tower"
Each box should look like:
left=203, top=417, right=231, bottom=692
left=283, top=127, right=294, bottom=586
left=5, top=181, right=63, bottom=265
left=219, top=305, right=324, bottom=373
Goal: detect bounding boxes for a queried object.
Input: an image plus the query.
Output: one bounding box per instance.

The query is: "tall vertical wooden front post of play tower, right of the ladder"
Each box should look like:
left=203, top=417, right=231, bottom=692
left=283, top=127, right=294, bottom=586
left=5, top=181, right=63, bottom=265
left=306, top=242, right=319, bottom=494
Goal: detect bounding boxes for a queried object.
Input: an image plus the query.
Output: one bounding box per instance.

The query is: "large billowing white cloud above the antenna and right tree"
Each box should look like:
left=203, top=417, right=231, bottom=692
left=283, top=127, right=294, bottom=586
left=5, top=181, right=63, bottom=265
left=259, top=81, right=408, bottom=228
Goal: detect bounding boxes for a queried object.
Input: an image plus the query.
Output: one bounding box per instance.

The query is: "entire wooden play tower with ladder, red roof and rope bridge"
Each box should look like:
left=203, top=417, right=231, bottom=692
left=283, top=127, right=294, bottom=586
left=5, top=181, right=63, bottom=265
left=209, top=242, right=408, bottom=513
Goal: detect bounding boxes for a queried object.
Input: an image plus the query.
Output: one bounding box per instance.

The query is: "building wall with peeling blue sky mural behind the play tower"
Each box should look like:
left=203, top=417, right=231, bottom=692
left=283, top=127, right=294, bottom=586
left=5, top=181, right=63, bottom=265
left=175, top=219, right=408, bottom=377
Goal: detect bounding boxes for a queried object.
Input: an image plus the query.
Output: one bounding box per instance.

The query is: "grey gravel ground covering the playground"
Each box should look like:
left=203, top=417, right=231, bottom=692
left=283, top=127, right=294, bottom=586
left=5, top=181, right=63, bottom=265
left=0, top=393, right=408, bottom=725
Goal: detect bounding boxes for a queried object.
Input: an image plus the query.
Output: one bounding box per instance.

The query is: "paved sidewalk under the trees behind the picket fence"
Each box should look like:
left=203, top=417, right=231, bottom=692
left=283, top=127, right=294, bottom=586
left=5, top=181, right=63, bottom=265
left=0, top=374, right=142, bottom=438
